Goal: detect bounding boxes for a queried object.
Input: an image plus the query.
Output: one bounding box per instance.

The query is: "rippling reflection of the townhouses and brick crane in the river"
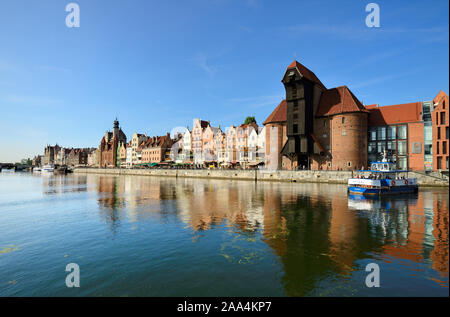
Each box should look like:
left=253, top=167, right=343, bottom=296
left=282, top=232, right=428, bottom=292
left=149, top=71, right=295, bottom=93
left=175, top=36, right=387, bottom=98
left=79, top=176, right=449, bottom=296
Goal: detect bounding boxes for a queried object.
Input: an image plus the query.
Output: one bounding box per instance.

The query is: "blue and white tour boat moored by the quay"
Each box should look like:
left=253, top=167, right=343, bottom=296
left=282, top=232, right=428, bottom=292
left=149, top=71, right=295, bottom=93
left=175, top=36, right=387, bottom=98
left=348, top=162, right=418, bottom=195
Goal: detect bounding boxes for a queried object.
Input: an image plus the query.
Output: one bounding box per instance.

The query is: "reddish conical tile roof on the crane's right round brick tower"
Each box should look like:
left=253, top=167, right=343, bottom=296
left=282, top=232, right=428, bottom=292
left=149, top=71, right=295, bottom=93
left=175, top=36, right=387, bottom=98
left=316, top=86, right=369, bottom=117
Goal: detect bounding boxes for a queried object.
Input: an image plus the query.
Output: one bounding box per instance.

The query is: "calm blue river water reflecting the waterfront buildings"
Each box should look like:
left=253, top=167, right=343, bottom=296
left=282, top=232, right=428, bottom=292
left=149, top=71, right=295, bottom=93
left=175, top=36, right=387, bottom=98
left=0, top=171, right=449, bottom=296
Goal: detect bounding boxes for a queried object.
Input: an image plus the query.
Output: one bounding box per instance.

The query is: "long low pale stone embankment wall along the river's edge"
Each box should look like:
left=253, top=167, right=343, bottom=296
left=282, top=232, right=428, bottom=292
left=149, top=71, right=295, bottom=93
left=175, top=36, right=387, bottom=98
left=74, top=168, right=449, bottom=187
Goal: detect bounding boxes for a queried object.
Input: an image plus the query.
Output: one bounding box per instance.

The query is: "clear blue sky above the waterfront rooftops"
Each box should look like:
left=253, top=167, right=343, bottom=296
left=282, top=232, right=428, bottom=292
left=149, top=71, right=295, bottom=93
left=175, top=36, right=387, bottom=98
left=0, top=0, right=449, bottom=162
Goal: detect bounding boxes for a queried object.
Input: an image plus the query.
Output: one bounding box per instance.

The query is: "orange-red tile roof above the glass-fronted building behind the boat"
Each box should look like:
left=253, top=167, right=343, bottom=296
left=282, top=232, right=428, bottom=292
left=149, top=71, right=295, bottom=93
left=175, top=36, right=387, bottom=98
left=369, top=102, right=422, bottom=126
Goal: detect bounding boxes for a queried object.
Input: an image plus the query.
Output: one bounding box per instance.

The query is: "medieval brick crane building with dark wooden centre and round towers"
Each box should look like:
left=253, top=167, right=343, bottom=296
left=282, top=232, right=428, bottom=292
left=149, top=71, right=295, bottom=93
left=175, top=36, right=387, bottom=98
left=264, top=61, right=369, bottom=170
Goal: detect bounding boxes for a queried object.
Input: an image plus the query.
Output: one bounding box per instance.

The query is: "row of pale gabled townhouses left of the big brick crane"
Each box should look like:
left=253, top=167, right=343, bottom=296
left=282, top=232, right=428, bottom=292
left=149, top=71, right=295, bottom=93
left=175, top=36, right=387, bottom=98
left=95, top=119, right=266, bottom=168
